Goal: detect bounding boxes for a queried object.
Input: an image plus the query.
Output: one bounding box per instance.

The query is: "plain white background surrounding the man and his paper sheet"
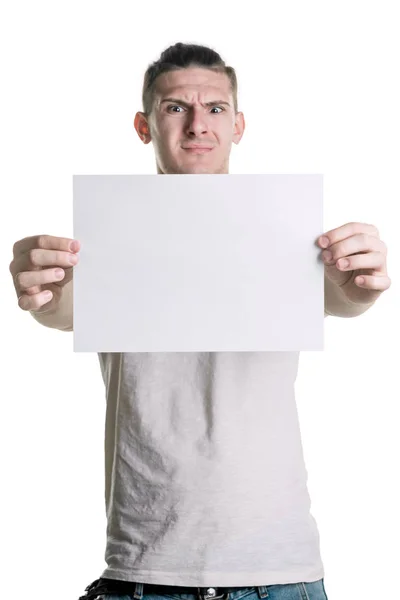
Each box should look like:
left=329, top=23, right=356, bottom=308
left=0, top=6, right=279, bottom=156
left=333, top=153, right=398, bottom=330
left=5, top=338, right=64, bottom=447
left=0, top=0, right=400, bottom=600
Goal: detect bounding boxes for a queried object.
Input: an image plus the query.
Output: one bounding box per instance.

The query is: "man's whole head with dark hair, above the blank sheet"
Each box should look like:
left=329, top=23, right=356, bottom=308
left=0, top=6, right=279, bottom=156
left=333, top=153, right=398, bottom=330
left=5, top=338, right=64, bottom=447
left=134, top=43, right=245, bottom=174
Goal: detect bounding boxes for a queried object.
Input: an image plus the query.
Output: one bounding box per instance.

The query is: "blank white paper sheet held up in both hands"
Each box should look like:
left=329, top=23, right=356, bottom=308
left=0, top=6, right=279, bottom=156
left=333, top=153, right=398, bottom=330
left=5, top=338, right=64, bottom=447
left=73, top=174, right=324, bottom=352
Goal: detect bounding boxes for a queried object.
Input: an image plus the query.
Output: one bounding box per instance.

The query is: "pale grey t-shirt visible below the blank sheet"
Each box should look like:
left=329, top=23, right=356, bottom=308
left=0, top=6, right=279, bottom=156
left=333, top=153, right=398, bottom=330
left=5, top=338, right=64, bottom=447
left=98, top=352, right=324, bottom=587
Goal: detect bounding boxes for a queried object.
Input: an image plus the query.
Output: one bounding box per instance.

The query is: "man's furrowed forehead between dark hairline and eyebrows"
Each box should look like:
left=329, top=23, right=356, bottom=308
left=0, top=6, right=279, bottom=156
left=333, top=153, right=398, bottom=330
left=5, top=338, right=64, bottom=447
left=155, top=68, right=231, bottom=100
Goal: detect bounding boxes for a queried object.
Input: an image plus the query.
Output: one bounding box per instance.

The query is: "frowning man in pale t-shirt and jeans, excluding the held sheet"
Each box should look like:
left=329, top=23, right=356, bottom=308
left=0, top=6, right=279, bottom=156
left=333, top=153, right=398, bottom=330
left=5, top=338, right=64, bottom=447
left=10, top=44, right=390, bottom=600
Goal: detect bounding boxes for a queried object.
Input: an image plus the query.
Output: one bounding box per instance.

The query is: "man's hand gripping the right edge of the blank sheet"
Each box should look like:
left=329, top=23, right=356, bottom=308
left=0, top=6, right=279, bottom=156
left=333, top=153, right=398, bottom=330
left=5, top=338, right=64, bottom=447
left=318, top=223, right=391, bottom=304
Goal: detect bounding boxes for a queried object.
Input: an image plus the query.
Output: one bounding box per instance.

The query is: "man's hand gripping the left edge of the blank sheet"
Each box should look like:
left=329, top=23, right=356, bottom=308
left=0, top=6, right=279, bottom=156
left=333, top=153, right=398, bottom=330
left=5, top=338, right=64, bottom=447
left=10, top=235, right=80, bottom=313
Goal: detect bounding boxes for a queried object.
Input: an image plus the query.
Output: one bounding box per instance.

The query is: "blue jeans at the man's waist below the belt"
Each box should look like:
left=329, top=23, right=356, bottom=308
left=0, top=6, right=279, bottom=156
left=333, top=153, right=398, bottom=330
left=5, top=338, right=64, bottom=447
left=97, top=579, right=328, bottom=600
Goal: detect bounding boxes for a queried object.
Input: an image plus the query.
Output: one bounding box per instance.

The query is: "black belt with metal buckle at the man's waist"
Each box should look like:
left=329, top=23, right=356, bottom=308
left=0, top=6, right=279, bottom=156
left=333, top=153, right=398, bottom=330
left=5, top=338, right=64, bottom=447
left=79, top=577, right=249, bottom=600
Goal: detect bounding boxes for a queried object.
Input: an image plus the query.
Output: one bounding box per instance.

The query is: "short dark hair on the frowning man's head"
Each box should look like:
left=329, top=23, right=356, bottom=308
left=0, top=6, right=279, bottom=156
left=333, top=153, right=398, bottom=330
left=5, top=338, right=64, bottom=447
left=142, top=42, right=238, bottom=115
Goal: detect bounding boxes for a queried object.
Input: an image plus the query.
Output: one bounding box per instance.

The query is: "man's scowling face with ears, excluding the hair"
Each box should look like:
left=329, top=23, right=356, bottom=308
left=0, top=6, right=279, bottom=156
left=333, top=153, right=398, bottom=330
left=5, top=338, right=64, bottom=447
left=135, top=67, right=245, bottom=174
